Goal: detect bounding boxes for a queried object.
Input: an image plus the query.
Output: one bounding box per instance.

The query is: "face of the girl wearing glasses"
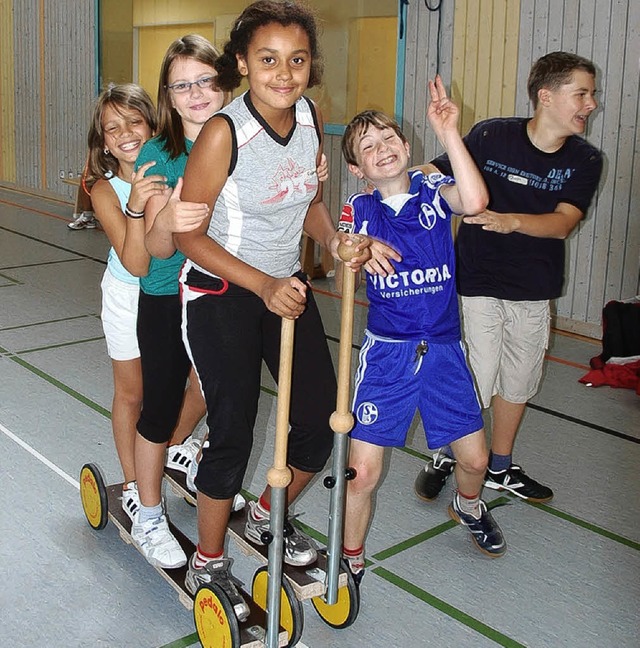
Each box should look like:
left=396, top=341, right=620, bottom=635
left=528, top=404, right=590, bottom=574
left=167, top=58, right=224, bottom=140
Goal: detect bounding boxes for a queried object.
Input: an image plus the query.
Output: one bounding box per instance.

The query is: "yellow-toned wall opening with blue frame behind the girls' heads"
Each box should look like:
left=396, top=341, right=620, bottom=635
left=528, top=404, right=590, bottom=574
left=100, top=0, right=400, bottom=125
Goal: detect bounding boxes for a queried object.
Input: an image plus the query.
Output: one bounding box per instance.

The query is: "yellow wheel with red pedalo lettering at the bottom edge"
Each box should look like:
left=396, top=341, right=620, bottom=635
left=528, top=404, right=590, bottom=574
left=193, top=583, right=240, bottom=648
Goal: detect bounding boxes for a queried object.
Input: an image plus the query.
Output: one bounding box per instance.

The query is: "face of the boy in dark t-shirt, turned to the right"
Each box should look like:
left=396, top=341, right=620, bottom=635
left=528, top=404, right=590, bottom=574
left=538, top=70, right=598, bottom=137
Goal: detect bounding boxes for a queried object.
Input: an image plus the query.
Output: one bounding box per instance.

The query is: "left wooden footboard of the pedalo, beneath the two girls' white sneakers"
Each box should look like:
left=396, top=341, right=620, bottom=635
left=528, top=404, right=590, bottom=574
left=106, top=484, right=288, bottom=648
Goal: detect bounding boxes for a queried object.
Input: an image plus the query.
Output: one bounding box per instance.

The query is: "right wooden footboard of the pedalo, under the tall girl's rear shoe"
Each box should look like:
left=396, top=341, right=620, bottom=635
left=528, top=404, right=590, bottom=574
left=164, top=468, right=347, bottom=601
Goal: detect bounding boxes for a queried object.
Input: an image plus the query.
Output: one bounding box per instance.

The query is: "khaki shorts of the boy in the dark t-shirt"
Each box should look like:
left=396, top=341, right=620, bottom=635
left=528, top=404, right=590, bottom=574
left=462, top=297, right=551, bottom=407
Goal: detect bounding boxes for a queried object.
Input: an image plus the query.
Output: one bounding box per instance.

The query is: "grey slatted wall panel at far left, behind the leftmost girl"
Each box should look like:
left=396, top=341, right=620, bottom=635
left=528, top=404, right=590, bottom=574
left=3, top=0, right=95, bottom=198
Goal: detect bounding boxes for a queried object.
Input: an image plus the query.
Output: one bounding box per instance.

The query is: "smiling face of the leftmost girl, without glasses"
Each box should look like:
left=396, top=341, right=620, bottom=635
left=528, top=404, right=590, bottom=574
left=101, top=104, right=153, bottom=168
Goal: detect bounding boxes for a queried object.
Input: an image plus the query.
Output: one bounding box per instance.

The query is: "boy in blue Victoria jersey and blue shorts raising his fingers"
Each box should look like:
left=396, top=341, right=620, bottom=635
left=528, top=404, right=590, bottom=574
left=338, top=77, right=506, bottom=582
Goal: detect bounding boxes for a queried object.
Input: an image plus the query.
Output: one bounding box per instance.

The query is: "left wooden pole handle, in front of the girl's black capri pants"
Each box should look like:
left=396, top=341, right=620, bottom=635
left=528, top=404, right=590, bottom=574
left=267, top=317, right=296, bottom=488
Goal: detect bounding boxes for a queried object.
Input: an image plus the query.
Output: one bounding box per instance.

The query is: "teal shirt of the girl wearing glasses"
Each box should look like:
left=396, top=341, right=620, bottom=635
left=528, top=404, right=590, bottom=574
left=136, top=137, right=193, bottom=295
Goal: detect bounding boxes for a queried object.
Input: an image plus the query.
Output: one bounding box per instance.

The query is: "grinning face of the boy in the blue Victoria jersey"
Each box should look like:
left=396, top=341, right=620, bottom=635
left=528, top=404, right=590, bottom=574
left=349, top=125, right=410, bottom=186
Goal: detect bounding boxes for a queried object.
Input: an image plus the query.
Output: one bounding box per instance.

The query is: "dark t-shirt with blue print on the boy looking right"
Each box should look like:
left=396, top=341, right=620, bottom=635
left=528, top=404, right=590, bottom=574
left=433, top=117, right=602, bottom=301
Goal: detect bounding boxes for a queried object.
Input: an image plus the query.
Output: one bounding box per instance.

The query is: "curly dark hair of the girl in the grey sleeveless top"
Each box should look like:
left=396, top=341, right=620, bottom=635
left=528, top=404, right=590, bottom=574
left=215, top=0, right=323, bottom=91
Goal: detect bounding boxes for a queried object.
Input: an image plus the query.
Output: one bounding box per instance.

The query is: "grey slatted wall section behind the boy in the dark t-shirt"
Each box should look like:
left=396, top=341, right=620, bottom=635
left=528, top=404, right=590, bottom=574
left=516, top=0, right=640, bottom=337
